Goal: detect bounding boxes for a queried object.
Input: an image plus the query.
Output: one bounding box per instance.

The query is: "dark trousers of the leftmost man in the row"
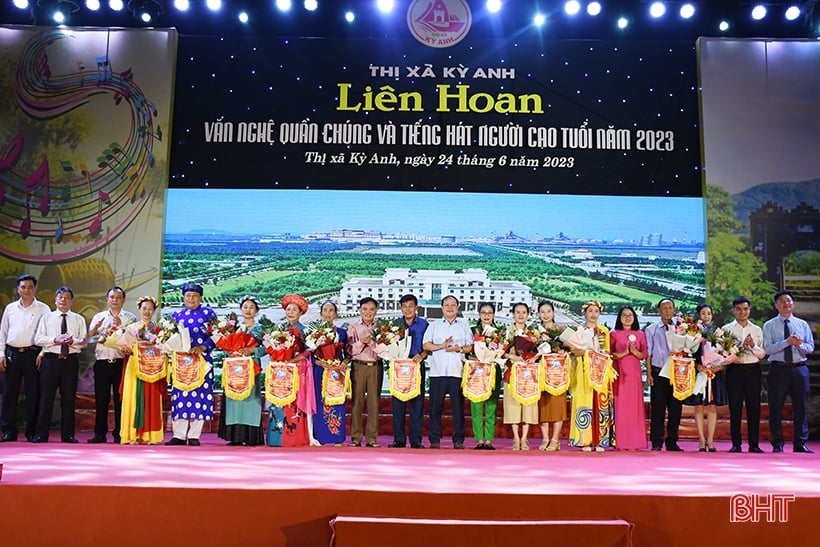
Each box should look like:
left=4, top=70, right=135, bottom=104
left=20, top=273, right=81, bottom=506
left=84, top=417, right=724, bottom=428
left=0, top=346, right=40, bottom=438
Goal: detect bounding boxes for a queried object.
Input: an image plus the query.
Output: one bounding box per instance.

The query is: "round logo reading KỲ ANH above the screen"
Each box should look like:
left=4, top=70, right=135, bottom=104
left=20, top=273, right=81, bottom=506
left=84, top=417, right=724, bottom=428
left=407, top=0, right=473, bottom=47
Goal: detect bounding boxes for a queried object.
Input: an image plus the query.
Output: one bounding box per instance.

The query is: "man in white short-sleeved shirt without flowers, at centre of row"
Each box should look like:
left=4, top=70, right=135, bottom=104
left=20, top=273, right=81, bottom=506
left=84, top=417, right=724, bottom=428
left=422, top=295, right=473, bottom=450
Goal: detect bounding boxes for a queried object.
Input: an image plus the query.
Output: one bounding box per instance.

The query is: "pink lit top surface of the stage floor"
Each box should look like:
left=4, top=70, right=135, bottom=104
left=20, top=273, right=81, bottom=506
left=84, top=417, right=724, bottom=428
left=0, top=434, right=820, bottom=497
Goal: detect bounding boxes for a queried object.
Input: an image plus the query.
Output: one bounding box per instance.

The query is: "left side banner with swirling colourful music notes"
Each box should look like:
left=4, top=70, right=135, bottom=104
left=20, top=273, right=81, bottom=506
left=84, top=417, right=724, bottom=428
left=0, top=28, right=177, bottom=391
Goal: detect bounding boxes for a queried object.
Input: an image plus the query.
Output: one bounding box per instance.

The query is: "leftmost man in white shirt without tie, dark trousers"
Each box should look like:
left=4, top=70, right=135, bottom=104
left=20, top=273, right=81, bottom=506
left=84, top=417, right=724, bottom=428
left=0, top=274, right=51, bottom=442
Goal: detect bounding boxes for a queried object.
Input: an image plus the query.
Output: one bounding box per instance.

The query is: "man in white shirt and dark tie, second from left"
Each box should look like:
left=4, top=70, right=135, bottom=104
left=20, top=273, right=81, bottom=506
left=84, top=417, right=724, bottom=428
left=31, top=287, right=88, bottom=444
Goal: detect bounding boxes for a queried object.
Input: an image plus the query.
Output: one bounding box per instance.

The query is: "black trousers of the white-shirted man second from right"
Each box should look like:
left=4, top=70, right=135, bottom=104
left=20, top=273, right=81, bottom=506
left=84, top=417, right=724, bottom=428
left=726, top=364, right=761, bottom=448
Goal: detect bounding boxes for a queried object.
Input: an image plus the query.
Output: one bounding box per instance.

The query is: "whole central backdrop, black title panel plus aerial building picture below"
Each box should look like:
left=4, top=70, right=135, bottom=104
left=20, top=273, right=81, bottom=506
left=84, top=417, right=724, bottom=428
left=163, top=31, right=705, bottom=342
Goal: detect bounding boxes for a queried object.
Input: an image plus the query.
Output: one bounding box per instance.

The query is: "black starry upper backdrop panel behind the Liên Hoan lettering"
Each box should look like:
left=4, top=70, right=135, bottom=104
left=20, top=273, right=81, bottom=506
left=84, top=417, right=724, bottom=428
left=170, top=35, right=702, bottom=196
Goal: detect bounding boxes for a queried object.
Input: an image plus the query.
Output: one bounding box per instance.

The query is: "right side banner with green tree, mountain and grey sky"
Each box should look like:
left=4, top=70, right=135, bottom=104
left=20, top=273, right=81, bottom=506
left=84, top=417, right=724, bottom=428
left=698, top=39, right=820, bottom=323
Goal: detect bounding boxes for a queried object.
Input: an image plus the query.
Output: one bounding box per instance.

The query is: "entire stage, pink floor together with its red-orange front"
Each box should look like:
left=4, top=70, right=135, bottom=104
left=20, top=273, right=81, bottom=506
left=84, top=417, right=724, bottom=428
left=0, top=434, right=820, bottom=547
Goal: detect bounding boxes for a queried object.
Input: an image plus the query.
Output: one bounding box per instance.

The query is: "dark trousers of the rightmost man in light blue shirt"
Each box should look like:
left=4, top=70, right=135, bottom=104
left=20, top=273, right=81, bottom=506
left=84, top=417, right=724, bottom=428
left=768, top=363, right=809, bottom=447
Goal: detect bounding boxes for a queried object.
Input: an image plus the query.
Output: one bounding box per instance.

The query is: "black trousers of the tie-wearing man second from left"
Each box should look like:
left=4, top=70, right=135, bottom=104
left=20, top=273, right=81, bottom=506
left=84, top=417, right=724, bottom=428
left=37, top=353, right=80, bottom=441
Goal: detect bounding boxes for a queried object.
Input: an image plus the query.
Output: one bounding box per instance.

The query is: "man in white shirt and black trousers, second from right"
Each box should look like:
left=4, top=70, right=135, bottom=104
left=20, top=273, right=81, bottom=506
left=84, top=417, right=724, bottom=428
left=723, top=296, right=766, bottom=454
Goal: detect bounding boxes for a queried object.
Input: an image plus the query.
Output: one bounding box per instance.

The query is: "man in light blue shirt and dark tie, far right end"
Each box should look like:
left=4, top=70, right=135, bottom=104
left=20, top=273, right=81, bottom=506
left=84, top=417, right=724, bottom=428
left=763, top=291, right=814, bottom=454
